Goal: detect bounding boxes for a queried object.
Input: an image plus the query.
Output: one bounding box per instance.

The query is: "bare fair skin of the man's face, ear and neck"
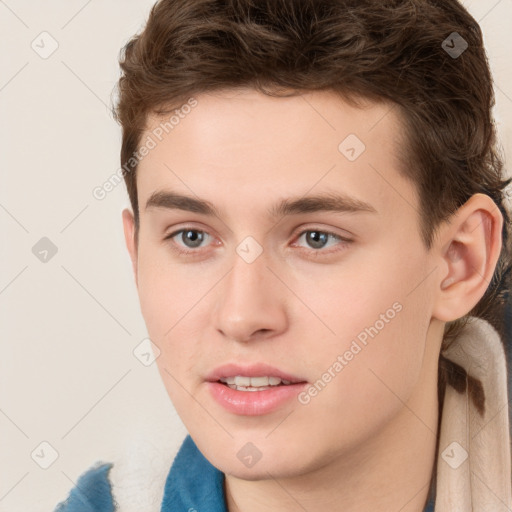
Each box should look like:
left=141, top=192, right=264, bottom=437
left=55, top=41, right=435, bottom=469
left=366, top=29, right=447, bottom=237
left=123, top=89, right=502, bottom=512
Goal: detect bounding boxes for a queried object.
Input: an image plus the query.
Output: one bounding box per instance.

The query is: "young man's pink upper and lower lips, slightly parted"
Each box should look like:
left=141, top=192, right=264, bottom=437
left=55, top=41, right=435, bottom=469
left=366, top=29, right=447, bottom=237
left=206, top=363, right=307, bottom=416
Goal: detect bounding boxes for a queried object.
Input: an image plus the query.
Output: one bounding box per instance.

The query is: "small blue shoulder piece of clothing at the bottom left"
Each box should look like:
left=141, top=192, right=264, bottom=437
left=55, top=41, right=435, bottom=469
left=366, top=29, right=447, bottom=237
left=54, top=462, right=115, bottom=512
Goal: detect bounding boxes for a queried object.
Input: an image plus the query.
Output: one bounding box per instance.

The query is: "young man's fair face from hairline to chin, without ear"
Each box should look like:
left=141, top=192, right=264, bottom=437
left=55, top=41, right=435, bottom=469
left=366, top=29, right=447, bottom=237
left=125, top=90, right=439, bottom=479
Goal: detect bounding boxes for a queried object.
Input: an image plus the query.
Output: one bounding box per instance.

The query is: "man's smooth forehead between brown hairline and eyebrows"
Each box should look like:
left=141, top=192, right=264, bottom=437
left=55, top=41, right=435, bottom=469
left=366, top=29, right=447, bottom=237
left=137, top=89, right=417, bottom=222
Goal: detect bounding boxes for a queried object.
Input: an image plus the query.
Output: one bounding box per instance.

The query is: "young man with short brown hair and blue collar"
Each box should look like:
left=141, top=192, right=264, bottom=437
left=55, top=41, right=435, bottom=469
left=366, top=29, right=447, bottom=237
left=54, top=0, right=512, bottom=512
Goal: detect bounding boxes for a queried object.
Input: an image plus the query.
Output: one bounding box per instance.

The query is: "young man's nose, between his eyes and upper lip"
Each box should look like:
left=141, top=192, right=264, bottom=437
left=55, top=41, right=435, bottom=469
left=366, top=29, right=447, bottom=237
left=214, top=248, right=287, bottom=342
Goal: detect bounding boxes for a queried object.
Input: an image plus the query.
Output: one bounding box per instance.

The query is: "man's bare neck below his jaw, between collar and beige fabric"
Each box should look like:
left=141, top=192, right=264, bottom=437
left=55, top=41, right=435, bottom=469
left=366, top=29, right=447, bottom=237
left=225, top=326, right=439, bottom=512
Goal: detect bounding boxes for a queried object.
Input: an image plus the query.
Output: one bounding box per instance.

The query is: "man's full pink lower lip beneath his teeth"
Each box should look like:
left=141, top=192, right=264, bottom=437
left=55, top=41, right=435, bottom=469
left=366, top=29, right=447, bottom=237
left=207, top=382, right=307, bottom=416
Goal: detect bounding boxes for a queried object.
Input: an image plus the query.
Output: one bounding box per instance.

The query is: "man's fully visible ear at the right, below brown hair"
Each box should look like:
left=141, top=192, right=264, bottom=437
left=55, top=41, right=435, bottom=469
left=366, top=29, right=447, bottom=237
left=433, top=194, right=503, bottom=322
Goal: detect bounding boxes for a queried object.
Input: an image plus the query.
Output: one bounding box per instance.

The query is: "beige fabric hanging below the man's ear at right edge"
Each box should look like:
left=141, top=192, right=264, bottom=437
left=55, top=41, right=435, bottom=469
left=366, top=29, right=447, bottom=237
left=435, top=318, right=512, bottom=512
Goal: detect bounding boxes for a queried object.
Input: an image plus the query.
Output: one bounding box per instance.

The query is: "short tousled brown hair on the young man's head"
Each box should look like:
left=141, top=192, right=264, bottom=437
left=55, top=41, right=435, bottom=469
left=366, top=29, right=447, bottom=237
left=114, top=0, right=511, bottom=420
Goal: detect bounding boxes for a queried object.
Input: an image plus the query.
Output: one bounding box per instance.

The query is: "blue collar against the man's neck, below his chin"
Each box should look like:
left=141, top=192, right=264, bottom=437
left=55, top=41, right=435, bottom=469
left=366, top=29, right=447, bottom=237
left=161, top=435, right=434, bottom=512
